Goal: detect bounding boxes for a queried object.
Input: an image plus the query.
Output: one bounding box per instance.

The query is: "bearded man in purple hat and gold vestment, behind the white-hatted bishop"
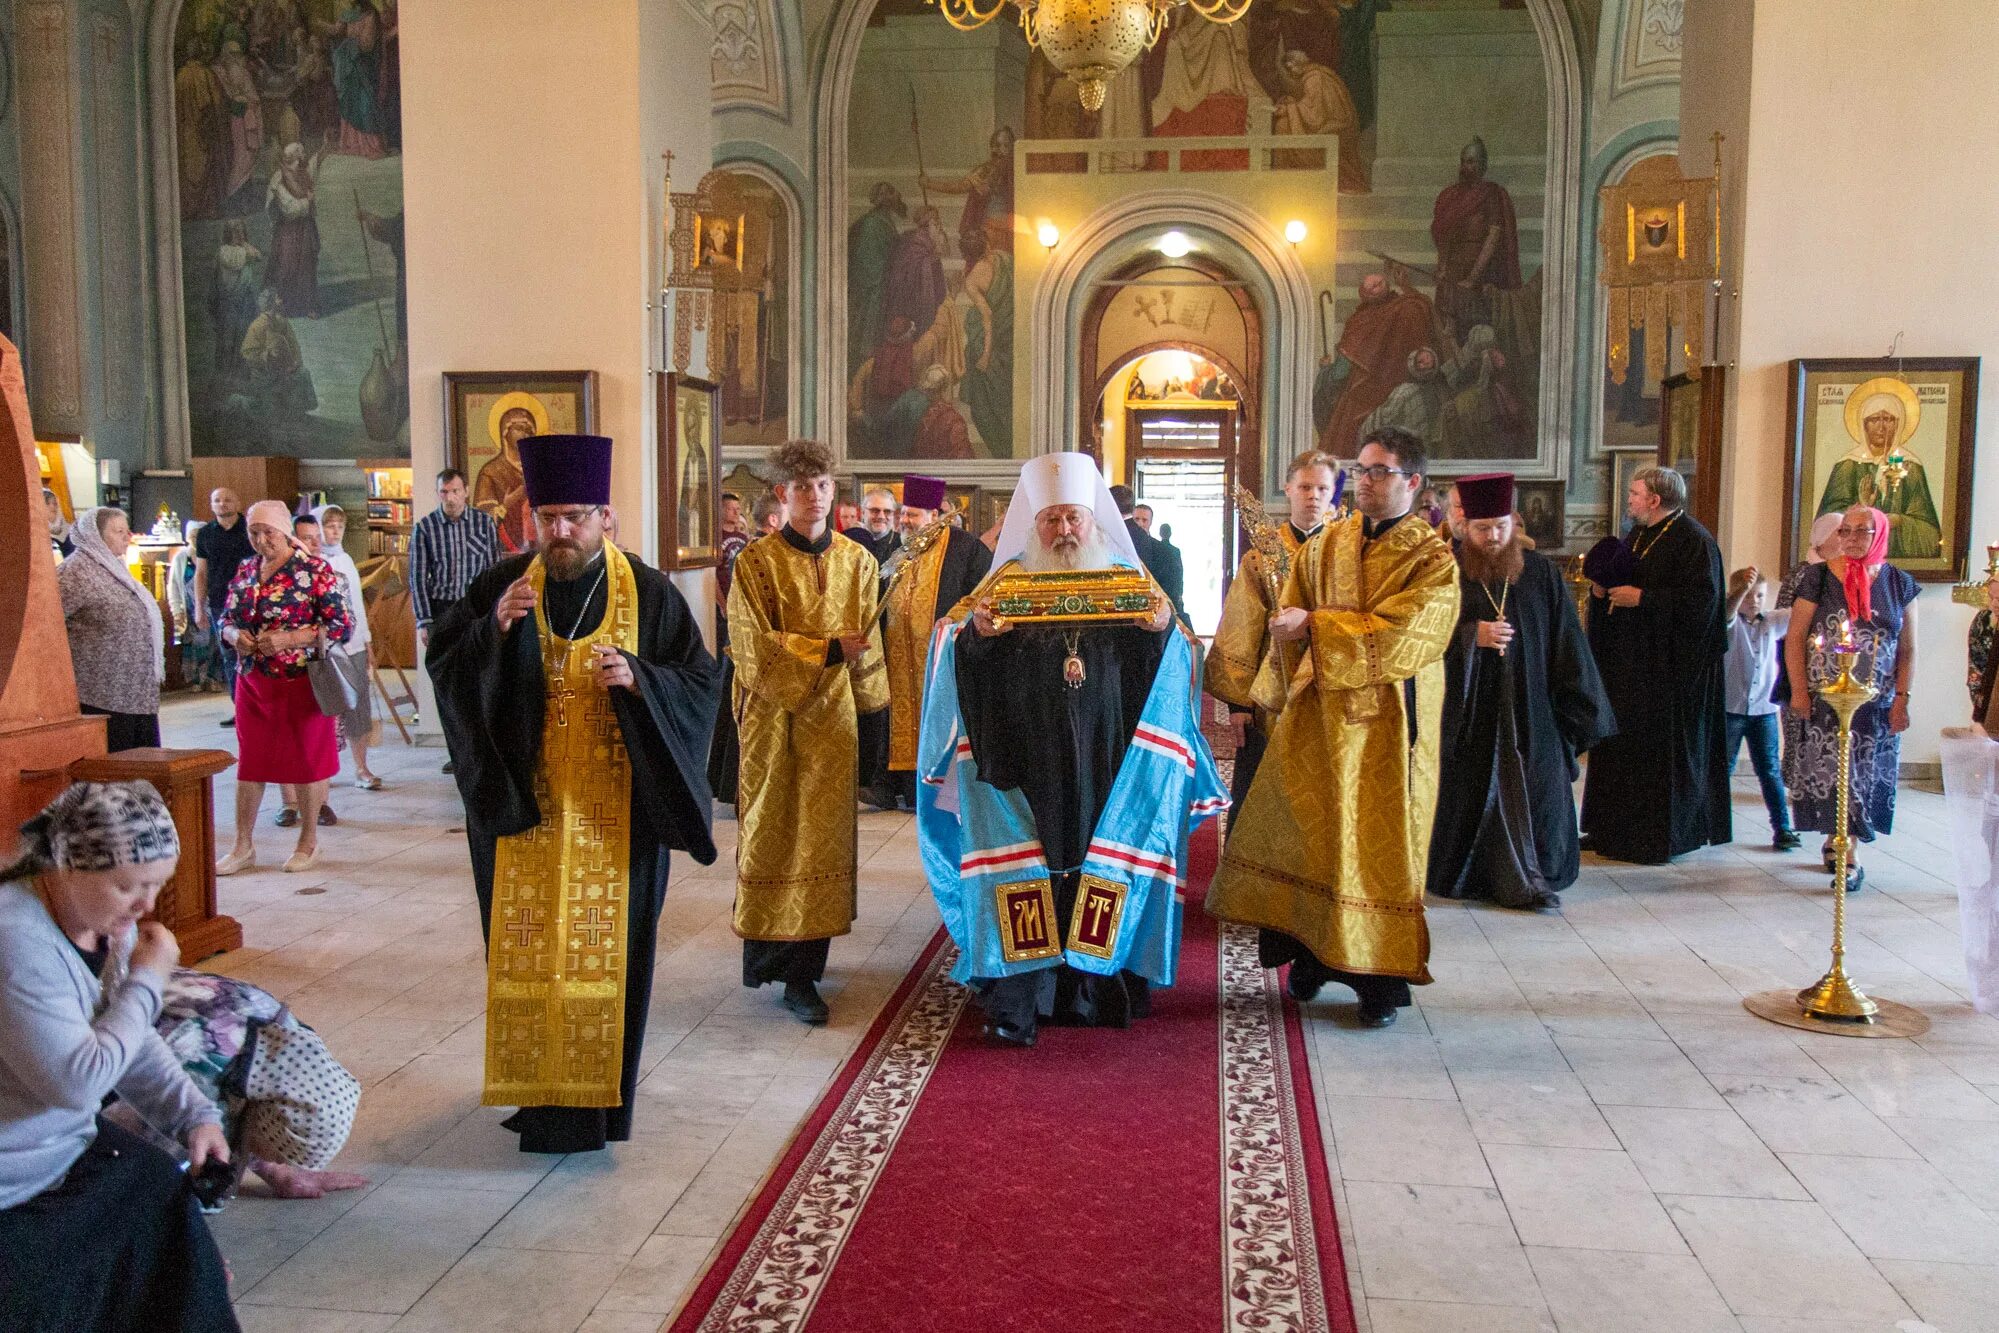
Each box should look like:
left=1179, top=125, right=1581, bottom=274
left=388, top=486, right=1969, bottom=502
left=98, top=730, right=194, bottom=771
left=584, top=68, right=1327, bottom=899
left=882, top=474, right=994, bottom=809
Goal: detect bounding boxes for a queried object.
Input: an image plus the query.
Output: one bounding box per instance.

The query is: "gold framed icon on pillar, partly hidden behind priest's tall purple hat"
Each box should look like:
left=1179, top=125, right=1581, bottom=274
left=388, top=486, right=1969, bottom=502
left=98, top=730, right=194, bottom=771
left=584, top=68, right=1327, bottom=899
left=444, top=370, right=598, bottom=552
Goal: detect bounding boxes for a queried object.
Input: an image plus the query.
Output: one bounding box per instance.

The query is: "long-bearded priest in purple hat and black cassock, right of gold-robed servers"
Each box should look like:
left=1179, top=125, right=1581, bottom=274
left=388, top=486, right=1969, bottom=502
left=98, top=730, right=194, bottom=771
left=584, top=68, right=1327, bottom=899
left=1427, top=472, right=1617, bottom=909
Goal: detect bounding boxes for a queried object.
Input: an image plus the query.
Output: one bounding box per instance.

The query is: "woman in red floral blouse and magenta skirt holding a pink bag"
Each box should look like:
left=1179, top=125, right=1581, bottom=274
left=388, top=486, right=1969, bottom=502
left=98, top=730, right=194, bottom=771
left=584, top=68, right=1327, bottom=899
left=216, top=500, right=354, bottom=875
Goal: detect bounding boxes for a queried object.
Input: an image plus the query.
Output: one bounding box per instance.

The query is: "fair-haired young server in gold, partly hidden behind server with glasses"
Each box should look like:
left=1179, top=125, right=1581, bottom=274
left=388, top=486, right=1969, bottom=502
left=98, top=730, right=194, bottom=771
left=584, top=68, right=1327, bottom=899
left=1201, top=450, right=1339, bottom=807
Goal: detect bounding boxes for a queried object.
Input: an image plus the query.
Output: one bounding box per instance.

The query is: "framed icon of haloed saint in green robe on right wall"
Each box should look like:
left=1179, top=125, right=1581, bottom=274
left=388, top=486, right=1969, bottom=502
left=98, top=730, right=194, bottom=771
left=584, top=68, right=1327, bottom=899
left=1783, top=356, right=1979, bottom=584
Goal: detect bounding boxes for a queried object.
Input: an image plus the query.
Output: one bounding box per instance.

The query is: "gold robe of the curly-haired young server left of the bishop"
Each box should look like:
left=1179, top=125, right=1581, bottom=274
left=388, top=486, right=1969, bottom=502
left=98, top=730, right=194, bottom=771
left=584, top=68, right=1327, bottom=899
left=730, top=534, right=888, bottom=939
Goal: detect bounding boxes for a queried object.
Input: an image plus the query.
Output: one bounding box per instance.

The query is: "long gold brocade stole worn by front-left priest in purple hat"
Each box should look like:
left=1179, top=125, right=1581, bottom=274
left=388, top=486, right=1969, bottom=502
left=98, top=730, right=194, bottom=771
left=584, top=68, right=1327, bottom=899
left=484, top=542, right=638, bottom=1107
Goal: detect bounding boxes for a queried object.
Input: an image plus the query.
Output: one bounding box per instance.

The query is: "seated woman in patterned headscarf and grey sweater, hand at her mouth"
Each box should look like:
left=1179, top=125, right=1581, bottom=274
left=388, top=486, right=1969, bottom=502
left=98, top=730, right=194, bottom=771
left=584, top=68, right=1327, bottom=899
left=0, top=781, right=238, bottom=1333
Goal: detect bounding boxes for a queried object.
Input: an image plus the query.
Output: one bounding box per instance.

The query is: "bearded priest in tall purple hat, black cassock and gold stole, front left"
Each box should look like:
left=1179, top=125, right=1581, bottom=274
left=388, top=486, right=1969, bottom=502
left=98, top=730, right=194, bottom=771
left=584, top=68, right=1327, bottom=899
left=426, top=436, right=720, bottom=1153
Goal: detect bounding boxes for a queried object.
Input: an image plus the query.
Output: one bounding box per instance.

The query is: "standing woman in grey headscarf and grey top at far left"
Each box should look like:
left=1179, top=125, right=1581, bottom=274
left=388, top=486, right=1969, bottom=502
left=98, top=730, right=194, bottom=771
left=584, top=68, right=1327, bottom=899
left=56, top=508, right=166, bottom=753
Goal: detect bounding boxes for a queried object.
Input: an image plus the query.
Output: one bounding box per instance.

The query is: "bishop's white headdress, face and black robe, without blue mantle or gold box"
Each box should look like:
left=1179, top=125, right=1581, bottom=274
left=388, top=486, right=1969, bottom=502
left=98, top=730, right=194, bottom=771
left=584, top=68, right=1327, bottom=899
left=956, top=454, right=1167, bottom=1045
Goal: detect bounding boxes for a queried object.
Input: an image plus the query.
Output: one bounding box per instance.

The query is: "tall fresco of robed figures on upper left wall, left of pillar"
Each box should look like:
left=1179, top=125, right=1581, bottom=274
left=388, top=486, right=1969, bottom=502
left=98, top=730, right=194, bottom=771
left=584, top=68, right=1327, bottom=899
left=174, top=0, right=410, bottom=458
